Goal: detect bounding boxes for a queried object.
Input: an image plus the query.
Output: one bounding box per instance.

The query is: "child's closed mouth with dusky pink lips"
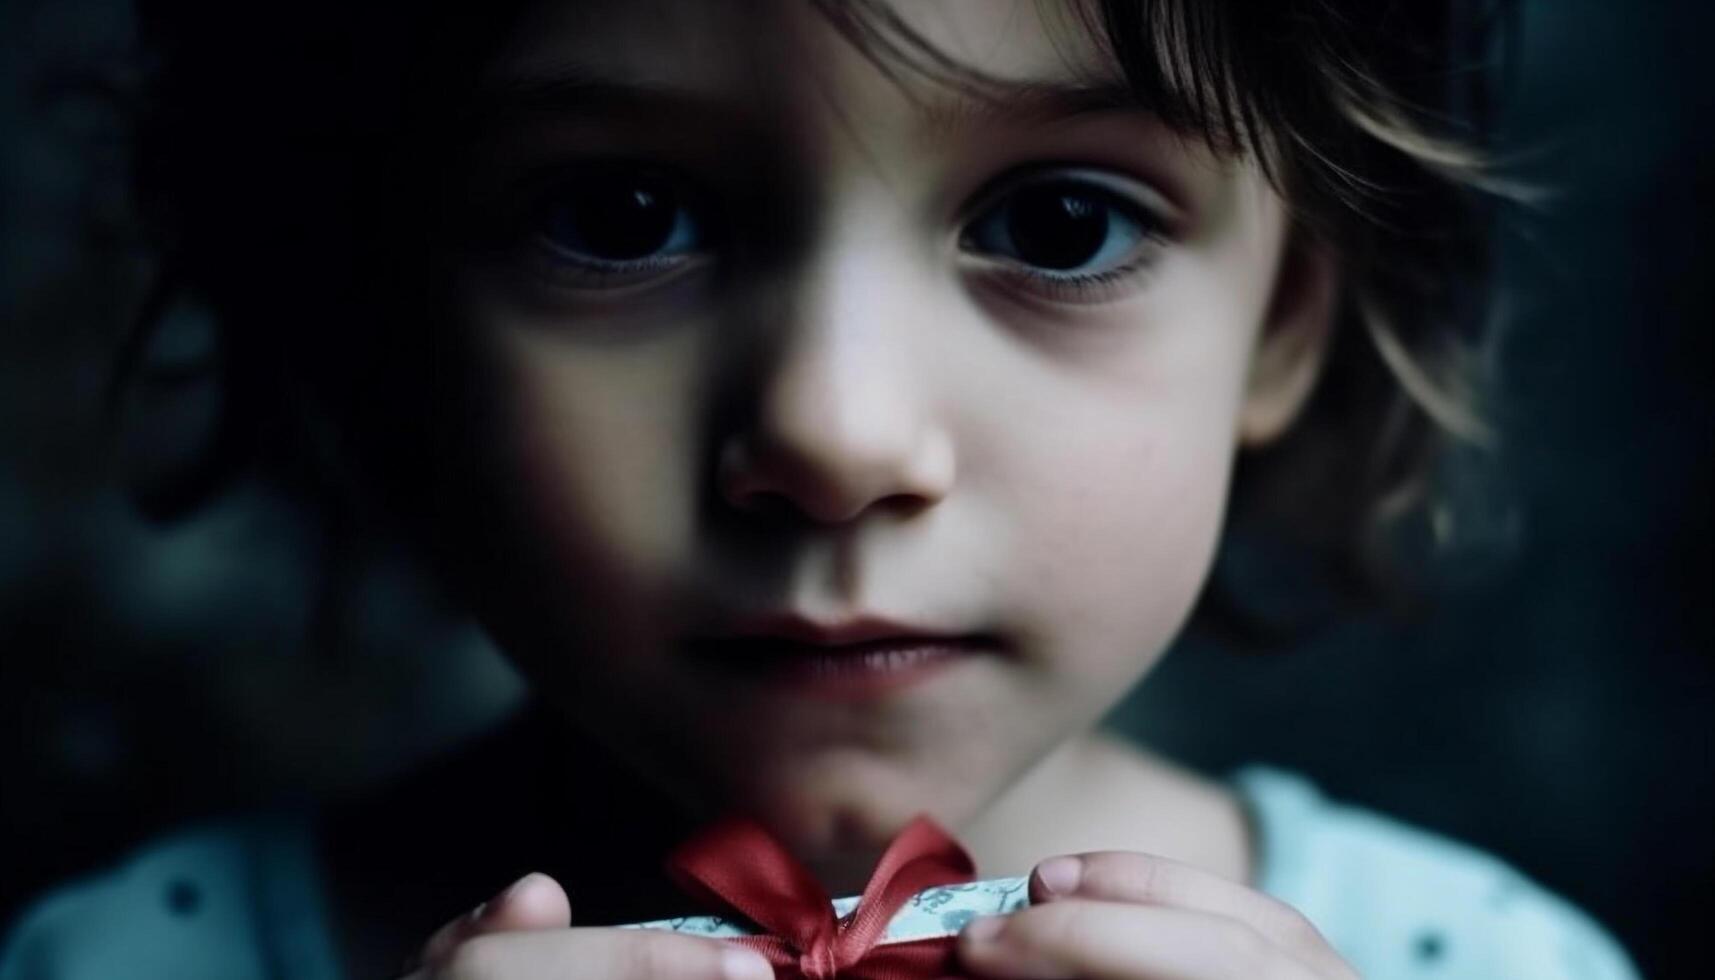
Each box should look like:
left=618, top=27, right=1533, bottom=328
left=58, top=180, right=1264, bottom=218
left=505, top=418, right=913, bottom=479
left=672, top=620, right=996, bottom=700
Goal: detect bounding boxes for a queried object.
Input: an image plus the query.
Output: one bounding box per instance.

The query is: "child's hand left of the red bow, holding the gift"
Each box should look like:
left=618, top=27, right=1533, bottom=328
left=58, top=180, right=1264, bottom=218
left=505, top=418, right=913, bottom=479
left=405, top=874, right=773, bottom=980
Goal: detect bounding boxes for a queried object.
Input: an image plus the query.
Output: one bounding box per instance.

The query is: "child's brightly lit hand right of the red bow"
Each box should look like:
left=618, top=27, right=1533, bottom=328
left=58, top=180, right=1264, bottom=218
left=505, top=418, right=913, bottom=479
left=959, top=851, right=1357, bottom=980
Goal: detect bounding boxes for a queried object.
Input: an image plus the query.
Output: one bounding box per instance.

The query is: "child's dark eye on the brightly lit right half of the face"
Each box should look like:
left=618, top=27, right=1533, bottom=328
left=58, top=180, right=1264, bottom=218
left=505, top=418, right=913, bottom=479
left=964, top=177, right=1156, bottom=276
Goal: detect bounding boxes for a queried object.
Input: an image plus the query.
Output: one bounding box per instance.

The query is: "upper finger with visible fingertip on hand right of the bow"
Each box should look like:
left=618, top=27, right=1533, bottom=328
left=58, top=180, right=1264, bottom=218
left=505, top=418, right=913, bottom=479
left=1031, top=851, right=1355, bottom=977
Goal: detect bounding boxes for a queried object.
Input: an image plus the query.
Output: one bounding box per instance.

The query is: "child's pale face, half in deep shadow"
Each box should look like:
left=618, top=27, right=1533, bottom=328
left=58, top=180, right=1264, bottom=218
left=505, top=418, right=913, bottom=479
left=454, top=0, right=1314, bottom=851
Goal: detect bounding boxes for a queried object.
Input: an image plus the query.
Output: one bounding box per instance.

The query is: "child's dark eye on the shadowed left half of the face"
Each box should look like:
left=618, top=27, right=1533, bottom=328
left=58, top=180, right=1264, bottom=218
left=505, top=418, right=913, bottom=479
left=535, top=170, right=707, bottom=283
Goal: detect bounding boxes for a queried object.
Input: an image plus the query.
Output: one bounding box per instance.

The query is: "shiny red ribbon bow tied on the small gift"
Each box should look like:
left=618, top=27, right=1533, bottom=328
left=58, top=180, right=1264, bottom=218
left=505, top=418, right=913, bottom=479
left=667, top=817, right=976, bottom=980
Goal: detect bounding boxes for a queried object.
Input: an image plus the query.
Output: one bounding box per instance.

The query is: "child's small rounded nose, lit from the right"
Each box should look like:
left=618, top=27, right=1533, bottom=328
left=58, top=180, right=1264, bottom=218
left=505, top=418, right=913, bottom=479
left=719, top=241, right=957, bottom=523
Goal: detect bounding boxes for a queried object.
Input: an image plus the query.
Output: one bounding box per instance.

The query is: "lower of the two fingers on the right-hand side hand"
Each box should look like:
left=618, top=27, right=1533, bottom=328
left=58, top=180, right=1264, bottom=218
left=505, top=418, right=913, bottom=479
left=959, top=899, right=1317, bottom=980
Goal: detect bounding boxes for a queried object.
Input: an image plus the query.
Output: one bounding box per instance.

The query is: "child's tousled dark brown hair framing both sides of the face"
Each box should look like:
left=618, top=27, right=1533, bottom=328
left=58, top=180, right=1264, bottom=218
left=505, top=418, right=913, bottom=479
left=124, top=0, right=1509, bottom=641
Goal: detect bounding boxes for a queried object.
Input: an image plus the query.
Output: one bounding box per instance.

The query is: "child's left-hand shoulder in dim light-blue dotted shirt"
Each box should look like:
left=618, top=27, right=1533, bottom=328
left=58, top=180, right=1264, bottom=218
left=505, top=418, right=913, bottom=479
left=0, top=815, right=336, bottom=980
